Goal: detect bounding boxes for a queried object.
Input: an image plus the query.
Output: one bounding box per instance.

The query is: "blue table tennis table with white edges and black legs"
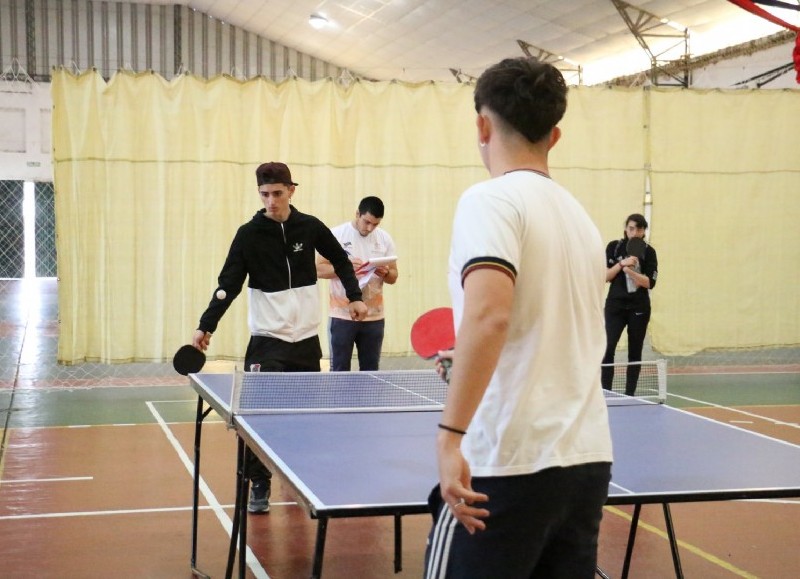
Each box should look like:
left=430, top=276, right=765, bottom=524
left=190, top=371, right=800, bottom=577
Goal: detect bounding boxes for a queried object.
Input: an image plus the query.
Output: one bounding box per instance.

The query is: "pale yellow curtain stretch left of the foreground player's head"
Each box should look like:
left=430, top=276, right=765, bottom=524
left=52, top=71, right=486, bottom=363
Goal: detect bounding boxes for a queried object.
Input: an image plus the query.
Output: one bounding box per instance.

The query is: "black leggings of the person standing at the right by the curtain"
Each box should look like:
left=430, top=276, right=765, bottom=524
left=601, top=301, right=650, bottom=396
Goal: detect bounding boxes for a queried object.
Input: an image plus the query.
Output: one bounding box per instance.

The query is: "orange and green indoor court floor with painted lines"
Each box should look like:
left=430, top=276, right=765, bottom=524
left=0, top=280, right=800, bottom=579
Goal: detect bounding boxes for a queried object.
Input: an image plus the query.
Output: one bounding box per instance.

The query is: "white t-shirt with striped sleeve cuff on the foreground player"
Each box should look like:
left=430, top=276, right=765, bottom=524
left=448, top=171, right=612, bottom=476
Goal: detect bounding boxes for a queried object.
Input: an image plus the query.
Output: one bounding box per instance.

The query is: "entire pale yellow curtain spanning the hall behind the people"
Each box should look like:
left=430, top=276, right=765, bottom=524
left=52, top=71, right=800, bottom=363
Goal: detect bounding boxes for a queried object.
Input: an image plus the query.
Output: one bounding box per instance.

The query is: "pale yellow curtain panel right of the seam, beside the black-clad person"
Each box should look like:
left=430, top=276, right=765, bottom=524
left=650, top=90, right=800, bottom=354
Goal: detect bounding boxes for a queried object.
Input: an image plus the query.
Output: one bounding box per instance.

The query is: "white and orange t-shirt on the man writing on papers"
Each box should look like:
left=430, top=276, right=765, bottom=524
left=330, top=221, right=397, bottom=322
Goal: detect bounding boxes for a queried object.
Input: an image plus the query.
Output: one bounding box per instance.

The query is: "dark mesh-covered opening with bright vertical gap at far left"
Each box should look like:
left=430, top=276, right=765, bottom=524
left=0, top=180, right=57, bottom=278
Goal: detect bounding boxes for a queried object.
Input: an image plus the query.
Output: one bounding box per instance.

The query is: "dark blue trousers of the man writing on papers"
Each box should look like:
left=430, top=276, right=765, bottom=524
left=329, top=318, right=384, bottom=372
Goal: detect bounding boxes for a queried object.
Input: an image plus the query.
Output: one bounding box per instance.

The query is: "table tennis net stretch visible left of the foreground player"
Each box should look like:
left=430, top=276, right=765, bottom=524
left=231, top=370, right=447, bottom=414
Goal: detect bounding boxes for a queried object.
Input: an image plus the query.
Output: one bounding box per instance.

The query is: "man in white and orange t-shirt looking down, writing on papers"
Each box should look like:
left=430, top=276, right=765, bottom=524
left=317, top=196, right=397, bottom=372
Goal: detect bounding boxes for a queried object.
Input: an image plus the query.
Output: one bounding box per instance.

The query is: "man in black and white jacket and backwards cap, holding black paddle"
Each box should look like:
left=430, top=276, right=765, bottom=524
left=192, top=162, right=367, bottom=512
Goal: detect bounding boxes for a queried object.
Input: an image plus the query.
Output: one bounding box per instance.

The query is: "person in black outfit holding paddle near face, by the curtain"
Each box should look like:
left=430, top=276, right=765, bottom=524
left=601, top=213, right=658, bottom=396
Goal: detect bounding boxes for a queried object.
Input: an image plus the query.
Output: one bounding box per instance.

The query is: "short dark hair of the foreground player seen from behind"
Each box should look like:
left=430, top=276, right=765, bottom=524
left=475, top=57, right=567, bottom=143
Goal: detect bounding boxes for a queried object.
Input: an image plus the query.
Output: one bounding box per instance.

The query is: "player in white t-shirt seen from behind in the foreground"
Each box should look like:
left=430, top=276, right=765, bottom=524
left=426, top=58, right=612, bottom=579
